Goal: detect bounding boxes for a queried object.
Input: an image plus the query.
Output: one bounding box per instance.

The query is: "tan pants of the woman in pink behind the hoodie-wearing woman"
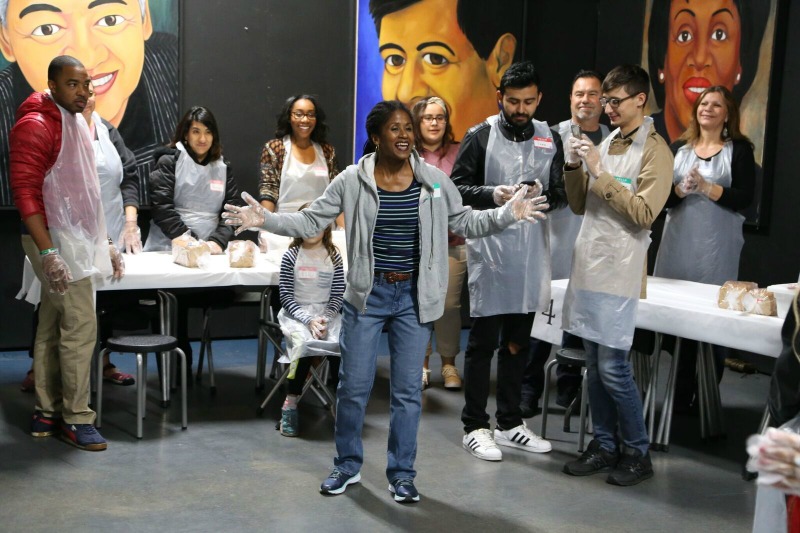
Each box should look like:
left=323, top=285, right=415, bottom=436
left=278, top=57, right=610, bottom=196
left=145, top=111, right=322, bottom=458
left=427, top=244, right=467, bottom=357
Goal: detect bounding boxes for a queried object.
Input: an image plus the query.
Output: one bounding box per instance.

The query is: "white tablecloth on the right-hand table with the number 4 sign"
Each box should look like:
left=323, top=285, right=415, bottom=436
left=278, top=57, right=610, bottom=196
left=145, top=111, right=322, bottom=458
left=534, top=277, right=783, bottom=357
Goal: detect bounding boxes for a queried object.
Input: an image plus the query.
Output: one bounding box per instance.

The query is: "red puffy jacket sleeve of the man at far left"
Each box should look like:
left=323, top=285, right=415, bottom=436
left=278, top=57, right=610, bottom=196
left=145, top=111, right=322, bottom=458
left=8, top=93, right=61, bottom=224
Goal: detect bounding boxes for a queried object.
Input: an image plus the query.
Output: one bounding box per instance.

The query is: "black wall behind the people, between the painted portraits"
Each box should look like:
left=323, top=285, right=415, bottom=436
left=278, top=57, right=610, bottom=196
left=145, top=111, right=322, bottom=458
left=0, top=0, right=800, bottom=349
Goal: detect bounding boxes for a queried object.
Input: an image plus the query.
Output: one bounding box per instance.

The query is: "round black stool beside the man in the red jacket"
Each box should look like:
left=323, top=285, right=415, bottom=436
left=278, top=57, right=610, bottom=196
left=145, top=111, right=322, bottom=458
left=95, top=334, right=187, bottom=439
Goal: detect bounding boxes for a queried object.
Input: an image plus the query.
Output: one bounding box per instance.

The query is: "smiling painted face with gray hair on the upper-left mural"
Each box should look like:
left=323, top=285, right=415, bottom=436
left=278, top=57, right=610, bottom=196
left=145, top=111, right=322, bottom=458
left=0, top=0, right=153, bottom=126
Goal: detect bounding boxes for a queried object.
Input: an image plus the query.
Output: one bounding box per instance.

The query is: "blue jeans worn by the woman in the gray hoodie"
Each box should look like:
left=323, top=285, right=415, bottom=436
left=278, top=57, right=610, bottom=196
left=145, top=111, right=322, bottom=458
left=333, top=278, right=433, bottom=481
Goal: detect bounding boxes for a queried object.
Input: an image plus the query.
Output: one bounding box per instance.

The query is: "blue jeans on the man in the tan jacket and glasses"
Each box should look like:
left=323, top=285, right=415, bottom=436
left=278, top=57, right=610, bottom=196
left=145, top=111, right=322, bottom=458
left=583, top=339, right=650, bottom=455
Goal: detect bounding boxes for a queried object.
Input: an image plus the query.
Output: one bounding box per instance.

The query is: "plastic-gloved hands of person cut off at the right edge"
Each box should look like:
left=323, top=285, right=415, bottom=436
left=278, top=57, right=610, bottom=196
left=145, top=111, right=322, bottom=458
left=747, top=416, right=800, bottom=495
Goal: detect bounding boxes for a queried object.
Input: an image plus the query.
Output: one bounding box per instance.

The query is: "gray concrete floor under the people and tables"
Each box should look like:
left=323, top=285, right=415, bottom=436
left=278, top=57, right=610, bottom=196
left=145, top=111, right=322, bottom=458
left=0, top=340, right=769, bottom=533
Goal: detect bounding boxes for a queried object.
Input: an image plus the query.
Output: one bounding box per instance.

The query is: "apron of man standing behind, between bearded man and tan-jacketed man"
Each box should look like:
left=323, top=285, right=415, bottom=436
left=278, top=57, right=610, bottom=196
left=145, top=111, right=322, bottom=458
left=547, top=120, right=608, bottom=279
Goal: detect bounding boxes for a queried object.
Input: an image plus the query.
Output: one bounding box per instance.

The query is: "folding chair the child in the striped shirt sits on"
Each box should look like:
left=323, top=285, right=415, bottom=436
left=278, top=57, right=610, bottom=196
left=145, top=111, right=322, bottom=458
left=257, top=287, right=336, bottom=419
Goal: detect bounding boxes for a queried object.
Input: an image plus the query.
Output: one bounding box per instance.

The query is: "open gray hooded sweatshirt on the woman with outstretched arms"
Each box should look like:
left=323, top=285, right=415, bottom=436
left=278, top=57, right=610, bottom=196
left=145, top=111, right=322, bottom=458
left=263, top=152, right=529, bottom=323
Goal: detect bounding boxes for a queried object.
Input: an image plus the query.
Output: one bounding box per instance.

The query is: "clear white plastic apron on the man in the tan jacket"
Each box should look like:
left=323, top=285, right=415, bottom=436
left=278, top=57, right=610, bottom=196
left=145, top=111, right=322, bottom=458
left=562, top=117, right=653, bottom=350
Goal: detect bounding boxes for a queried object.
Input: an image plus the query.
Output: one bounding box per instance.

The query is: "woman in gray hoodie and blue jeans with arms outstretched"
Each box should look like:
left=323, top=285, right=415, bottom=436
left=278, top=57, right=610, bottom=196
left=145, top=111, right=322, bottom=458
left=223, top=101, right=547, bottom=503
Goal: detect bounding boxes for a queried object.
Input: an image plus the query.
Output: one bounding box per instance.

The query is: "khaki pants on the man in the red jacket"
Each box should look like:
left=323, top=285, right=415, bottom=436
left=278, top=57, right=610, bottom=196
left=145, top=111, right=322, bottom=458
left=22, top=235, right=97, bottom=424
